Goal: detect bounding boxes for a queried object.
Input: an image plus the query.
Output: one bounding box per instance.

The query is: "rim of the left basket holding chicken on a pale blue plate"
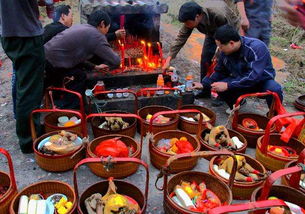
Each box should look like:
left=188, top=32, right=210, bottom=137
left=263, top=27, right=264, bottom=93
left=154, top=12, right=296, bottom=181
left=33, top=130, right=83, bottom=159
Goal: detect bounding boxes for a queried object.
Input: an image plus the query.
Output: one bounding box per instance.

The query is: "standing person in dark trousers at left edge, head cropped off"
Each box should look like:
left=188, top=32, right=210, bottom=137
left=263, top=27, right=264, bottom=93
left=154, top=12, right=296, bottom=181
left=0, top=0, right=45, bottom=153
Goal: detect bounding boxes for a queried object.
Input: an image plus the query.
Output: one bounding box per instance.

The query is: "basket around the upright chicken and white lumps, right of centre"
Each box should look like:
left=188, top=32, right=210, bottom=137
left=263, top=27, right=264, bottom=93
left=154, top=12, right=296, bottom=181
left=199, top=127, right=248, bottom=153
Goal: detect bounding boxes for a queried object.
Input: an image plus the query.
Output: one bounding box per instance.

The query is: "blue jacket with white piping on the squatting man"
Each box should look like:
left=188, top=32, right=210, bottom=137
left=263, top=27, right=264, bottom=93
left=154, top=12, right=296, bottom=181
left=202, top=36, right=275, bottom=90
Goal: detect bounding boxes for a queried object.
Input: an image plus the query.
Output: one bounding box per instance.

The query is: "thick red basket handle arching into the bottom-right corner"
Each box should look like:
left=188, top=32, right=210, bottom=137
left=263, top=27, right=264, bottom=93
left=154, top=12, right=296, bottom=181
left=258, top=164, right=305, bottom=201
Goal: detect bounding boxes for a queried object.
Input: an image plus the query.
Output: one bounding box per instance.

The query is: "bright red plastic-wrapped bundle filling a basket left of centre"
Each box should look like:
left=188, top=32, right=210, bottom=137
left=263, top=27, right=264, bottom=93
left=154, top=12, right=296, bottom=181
left=94, top=137, right=135, bottom=157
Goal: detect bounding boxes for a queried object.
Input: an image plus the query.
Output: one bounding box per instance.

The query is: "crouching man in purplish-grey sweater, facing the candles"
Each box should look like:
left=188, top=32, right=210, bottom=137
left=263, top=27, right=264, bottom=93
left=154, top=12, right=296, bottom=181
left=44, top=10, right=121, bottom=100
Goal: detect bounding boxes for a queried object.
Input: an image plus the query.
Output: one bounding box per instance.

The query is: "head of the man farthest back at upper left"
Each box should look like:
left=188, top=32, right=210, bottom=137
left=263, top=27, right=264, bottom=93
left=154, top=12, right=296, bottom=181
left=53, top=4, right=73, bottom=27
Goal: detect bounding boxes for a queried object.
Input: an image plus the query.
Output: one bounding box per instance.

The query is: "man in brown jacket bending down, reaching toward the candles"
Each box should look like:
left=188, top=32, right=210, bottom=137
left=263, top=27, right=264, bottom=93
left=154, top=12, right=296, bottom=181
left=163, top=0, right=238, bottom=97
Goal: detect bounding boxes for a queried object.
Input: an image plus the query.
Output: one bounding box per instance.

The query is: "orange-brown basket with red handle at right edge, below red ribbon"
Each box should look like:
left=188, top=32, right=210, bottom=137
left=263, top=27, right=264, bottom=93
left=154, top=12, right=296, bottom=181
left=255, top=112, right=305, bottom=171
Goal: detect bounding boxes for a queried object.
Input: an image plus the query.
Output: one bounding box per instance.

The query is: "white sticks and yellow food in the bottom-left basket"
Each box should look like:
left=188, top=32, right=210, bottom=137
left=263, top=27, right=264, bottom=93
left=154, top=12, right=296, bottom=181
left=18, top=194, right=73, bottom=214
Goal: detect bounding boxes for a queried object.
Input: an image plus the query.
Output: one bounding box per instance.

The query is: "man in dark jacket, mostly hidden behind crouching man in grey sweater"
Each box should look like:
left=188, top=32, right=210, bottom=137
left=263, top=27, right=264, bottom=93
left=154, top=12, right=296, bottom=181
left=43, top=5, right=73, bottom=43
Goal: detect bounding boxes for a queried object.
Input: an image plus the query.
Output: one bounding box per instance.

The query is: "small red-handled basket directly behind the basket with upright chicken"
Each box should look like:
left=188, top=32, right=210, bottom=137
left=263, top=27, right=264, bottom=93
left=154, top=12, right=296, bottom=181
left=179, top=105, right=216, bottom=134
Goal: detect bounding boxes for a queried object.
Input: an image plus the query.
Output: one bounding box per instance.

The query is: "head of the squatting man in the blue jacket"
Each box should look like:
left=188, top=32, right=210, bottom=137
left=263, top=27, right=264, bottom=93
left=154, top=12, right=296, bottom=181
left=214, top=25, right=241, bottom=55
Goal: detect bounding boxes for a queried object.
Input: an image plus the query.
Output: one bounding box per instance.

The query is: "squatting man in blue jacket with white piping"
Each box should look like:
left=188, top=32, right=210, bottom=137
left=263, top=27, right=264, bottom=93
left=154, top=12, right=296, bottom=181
left=194, top=25, right=283, bottom=109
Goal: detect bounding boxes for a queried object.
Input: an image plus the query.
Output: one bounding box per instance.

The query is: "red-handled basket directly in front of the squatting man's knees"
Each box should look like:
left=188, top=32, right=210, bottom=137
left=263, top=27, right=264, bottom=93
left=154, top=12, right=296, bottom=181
left=232, top=92, right=279, bottom=148
